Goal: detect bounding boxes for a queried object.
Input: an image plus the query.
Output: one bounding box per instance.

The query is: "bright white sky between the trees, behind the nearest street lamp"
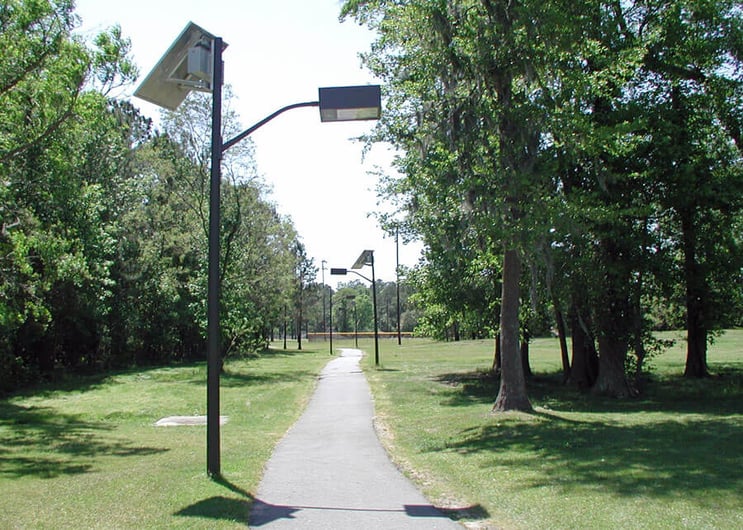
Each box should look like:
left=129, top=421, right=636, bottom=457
left=76, top=0, right=421, bottom=285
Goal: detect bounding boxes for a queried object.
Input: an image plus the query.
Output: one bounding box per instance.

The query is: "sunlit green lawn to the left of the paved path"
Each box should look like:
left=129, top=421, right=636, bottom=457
left=0, top=345, right=329, bottom=529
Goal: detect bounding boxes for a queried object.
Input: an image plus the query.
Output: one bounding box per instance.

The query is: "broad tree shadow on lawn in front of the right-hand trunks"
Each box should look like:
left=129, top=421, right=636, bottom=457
left=444, top=413, right=743, bottom=498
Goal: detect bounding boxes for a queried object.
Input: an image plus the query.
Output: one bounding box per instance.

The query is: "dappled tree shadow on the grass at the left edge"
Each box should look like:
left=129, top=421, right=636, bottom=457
left=0, top=402, right=167, bottom=478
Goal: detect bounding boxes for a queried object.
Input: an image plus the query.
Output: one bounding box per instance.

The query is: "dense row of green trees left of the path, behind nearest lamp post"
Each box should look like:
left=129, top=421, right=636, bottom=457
left=0, top=0, right=306, bottom=393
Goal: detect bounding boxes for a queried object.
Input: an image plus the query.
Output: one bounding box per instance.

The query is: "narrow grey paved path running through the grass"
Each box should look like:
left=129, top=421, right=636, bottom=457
left=250, top=350, right=462, bottom=530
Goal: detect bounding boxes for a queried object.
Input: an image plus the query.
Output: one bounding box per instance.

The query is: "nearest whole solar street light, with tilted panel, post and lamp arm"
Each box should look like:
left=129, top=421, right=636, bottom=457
left=134, top=22, right=382, bottom=477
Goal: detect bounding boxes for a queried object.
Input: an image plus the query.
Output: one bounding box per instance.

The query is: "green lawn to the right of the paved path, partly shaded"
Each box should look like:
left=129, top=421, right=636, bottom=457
left=354, top=331, right=743, bottom=529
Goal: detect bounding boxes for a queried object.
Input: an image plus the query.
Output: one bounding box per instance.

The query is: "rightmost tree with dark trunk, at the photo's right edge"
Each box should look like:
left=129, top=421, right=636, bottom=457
left=635, top=0, right=743, bottom=377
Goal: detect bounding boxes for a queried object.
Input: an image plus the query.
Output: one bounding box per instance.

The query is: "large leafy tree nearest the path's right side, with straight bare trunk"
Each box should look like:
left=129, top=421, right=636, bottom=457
left=345, top=0, right=588, bottom=410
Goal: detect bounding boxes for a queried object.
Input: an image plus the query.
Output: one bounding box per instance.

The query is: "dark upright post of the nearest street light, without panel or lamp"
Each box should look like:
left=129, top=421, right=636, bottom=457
left=206, top=37, right=224, bottom=478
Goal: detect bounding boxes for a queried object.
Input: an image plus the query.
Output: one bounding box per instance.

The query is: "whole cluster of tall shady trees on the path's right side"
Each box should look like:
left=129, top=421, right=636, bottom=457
left=342, top=0, right=743, bottom=410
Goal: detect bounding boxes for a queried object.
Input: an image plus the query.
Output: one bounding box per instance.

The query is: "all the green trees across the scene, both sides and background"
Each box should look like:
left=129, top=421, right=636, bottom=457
left=0, top=0, right=743, bottom=402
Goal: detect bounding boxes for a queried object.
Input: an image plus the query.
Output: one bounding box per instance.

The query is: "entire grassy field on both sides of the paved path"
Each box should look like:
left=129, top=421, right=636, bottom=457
left=0, top=331, right=743, bottom=529
